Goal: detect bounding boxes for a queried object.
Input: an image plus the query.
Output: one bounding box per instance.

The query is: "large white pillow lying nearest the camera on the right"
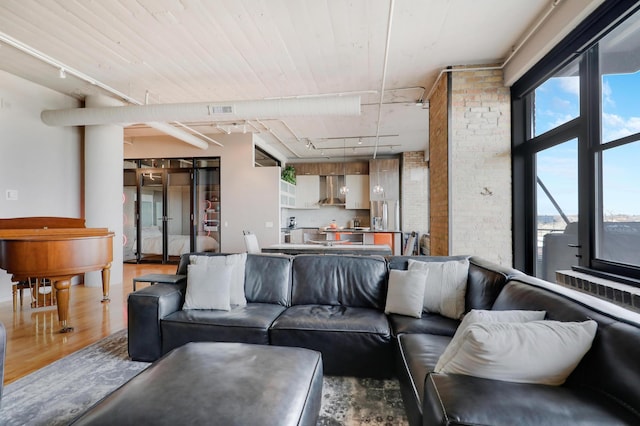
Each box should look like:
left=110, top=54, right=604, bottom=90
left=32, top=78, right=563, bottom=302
left=437, top=320, right=598, bottom=386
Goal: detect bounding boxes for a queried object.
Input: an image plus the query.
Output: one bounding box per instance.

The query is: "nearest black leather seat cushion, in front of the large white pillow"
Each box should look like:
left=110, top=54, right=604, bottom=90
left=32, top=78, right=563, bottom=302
left=423, top=373, right=640, bottom=426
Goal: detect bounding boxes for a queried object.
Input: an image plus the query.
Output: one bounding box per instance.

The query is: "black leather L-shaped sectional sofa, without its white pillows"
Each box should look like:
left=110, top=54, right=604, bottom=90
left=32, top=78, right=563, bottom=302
left=128, top=254, right=640, bottom=425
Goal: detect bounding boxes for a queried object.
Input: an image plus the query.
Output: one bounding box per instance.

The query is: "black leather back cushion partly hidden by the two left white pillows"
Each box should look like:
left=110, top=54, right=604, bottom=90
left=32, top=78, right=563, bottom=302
left=176, top=252, right=293, bottom=306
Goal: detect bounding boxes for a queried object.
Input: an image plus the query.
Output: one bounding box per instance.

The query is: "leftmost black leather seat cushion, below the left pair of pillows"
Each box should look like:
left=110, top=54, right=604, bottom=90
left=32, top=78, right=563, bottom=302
left=161, top=303, right=286, bottom=354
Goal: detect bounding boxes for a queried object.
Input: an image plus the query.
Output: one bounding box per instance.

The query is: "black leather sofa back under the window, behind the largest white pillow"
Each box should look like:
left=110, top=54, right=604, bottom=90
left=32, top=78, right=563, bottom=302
left=493, top=275, right=640, bottom=410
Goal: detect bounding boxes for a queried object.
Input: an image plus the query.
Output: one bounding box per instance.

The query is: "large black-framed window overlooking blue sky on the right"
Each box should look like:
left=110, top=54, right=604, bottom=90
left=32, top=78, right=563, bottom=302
left=512, top=1, right=640, bottom=280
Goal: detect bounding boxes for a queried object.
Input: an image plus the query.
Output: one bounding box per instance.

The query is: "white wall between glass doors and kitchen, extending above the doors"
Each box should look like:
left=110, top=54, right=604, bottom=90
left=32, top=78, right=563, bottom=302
left=124, top=134, right=281, bottom=253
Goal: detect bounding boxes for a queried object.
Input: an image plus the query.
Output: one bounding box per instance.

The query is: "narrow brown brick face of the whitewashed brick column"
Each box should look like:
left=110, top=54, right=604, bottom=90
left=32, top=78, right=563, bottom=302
left=429, top=74, right=449, bottom=256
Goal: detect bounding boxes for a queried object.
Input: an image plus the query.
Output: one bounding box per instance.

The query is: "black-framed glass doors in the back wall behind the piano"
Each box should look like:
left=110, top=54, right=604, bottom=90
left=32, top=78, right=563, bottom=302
left=122, top=158, right=221, bottom=263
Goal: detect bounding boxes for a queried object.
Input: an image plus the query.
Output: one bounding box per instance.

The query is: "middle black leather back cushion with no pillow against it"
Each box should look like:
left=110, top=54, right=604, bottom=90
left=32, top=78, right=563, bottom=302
left=291, top=254, right=387, bottom=311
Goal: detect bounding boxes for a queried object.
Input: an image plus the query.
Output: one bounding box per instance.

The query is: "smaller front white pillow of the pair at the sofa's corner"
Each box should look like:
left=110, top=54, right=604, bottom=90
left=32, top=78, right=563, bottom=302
left=384, top=269, right=429, bottom=318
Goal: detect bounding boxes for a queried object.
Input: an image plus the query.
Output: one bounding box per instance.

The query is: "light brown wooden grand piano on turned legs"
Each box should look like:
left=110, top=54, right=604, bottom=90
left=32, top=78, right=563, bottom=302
left=0, top=217, right=114, bottom=333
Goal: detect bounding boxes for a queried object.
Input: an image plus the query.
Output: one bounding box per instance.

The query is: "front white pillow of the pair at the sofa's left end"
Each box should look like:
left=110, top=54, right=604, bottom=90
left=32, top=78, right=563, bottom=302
left=182, top=263, right=233, bottom=311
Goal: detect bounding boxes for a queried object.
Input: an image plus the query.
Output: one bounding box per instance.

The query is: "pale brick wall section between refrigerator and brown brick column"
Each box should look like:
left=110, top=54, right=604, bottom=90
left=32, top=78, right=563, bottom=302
left=400, top=151, right=429, bottom=251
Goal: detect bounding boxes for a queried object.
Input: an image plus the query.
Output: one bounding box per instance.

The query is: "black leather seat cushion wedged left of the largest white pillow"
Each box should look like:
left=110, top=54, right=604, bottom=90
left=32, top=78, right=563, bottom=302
left=396, top=334, right=451, bottom=425
